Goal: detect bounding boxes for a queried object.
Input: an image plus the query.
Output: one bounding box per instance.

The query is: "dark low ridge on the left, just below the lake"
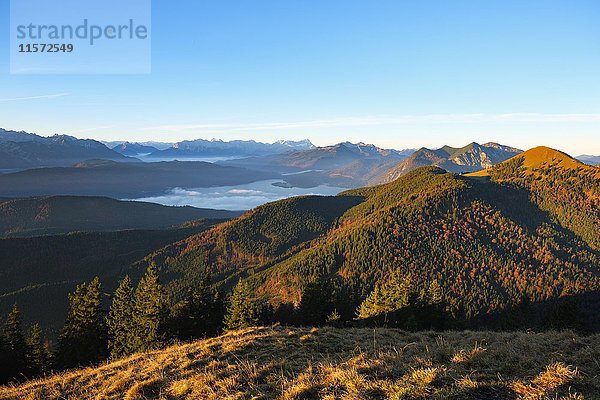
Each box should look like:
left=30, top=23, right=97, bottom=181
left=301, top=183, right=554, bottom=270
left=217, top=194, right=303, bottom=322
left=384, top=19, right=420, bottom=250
left=0, top=196, right=240, bottom=237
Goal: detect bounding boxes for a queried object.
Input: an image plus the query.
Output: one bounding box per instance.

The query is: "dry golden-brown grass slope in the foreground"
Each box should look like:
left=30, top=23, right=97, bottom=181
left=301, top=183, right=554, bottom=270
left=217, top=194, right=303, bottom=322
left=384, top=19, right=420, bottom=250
left=0, top=327, right=600, bottom=400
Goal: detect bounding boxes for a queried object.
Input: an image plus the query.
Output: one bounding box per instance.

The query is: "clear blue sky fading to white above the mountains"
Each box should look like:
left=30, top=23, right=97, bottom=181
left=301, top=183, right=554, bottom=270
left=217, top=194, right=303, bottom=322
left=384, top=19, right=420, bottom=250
left=0, top=0, right=600, bottom=154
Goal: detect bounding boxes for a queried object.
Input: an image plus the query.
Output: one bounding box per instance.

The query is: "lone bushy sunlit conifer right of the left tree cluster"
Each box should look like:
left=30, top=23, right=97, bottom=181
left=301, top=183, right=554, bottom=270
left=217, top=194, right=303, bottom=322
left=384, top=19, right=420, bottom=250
left=225, top=280, right=262, bottom=330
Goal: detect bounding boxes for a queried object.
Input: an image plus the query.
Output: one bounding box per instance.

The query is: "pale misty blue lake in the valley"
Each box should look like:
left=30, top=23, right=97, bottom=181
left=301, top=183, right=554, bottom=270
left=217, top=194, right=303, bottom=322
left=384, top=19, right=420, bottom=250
left=132, top=180, right=347, bottom=211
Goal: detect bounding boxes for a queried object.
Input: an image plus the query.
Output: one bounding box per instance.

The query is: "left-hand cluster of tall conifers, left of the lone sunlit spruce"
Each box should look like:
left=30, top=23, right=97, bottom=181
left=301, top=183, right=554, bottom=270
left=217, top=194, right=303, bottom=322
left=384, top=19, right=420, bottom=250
left=0, top=265, right=224, bottom=383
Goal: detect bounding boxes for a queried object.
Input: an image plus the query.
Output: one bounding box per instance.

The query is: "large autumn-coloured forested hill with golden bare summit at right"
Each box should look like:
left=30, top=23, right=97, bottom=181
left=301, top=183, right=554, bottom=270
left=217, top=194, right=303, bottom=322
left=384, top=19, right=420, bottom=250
left=147, top=148, right=600, bottom=330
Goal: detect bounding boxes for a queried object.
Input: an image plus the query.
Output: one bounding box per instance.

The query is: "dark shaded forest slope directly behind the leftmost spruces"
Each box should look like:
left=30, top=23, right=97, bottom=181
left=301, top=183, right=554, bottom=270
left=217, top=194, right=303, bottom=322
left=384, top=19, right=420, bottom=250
left=0, top=220, right=216, bottom=337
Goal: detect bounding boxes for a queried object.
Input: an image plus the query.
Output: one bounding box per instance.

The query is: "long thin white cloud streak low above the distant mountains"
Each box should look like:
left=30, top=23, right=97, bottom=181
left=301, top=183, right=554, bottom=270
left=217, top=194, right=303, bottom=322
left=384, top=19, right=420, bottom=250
left=143, top=113, right=600, bottom=132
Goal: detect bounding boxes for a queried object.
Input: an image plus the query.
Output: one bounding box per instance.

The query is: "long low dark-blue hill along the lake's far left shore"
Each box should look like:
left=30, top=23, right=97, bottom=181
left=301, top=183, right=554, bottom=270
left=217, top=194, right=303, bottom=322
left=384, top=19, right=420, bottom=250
left=0, top=160, right=280, bottom=198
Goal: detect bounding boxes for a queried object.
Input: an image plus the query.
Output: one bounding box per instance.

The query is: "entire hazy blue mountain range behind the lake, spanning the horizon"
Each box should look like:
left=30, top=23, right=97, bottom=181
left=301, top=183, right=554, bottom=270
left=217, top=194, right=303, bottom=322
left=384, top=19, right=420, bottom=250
left=0, top=130, right=521, bottom=197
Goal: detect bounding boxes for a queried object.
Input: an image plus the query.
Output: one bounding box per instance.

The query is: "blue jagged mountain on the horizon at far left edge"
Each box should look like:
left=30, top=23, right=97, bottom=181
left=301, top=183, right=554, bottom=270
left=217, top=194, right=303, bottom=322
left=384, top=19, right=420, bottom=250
left=0, top=129, right=138, bottom=170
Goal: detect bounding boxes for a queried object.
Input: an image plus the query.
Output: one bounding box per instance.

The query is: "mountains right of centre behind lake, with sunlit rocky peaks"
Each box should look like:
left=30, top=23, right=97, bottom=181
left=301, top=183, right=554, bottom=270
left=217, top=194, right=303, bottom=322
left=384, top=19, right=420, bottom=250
left=220, top=142, right=522, bottom=188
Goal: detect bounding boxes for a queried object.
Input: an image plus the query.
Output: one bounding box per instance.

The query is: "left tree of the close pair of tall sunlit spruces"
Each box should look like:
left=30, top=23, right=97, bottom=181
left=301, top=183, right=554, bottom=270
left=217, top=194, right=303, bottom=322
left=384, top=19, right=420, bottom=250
left=107, top=276, right=134, bottom=358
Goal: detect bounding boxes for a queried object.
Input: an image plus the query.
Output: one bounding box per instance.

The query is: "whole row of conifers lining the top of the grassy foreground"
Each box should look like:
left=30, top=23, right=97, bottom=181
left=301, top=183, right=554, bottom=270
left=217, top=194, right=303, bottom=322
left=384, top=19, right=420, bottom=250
left=0, top=265, right=598, bottom=383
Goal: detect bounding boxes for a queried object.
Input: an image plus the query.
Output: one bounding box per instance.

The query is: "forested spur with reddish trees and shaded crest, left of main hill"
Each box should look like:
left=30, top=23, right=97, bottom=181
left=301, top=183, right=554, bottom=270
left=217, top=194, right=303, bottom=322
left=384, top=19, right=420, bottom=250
left=147, top=196, right=362, bottom=296
